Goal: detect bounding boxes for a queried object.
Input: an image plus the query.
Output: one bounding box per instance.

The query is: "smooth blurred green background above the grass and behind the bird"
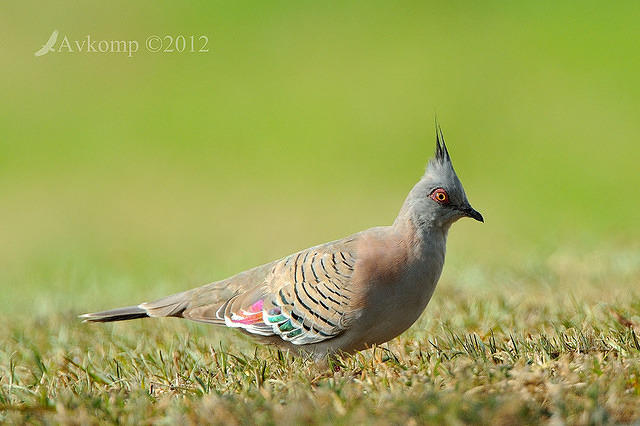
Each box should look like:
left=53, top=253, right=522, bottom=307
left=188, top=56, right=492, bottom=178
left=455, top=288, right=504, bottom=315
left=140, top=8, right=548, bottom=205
left=0, top=1, right=640, bottom=315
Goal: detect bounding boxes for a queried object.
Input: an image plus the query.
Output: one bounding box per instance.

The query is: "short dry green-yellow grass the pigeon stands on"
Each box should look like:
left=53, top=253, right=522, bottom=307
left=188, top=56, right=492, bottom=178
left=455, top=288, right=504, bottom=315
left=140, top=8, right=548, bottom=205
left=0, top=249, right=640, bottom=424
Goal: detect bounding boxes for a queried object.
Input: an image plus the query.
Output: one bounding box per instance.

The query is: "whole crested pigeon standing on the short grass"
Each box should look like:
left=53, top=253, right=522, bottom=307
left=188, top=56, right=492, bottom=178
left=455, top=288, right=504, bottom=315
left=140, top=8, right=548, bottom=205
left=80, top=123, right=484, bottom=359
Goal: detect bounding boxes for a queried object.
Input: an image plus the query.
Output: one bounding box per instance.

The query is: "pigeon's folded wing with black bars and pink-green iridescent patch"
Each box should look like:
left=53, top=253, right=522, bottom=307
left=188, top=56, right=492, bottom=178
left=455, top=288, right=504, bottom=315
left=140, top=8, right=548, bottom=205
left=140, top=238, right=359, bottom=345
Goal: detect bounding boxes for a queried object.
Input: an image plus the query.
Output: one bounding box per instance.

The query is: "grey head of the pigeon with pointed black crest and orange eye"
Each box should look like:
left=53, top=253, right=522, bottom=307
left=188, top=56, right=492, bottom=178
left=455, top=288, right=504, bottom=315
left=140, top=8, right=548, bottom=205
left=405, top=123, right=484, bottom=230
